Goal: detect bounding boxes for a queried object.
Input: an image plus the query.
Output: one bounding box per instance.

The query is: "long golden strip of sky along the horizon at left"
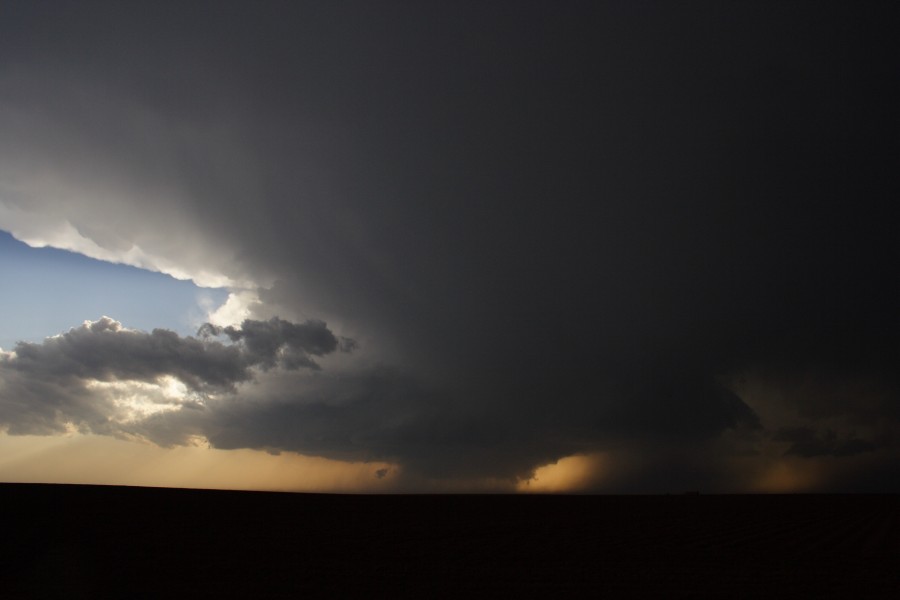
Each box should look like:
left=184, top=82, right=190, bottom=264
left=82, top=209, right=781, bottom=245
left=0, top=432, right=398, bottom=493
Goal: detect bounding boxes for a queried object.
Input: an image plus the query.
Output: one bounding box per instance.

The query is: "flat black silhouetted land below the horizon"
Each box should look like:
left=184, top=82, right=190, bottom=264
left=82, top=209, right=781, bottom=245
left=0, top=484, right=900, bottom=598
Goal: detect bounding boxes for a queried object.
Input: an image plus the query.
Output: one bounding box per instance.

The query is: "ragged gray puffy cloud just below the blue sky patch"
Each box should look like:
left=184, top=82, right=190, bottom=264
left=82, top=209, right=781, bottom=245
left=0, top=317, right=348, bottom=434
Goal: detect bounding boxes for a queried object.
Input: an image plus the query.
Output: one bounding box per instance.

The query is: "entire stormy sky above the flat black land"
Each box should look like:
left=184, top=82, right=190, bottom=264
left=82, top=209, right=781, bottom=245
left=0, top=1, right=900, bottom=493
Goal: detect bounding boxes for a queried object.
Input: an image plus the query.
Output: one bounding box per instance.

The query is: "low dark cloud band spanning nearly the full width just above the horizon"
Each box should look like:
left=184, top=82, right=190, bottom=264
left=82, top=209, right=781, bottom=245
left=0, top=317, right=880, bottom=492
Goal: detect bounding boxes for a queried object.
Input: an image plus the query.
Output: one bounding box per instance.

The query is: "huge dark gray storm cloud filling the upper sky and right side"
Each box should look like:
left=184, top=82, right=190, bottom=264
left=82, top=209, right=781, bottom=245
left=0, top=2, right=900, bottom=487
